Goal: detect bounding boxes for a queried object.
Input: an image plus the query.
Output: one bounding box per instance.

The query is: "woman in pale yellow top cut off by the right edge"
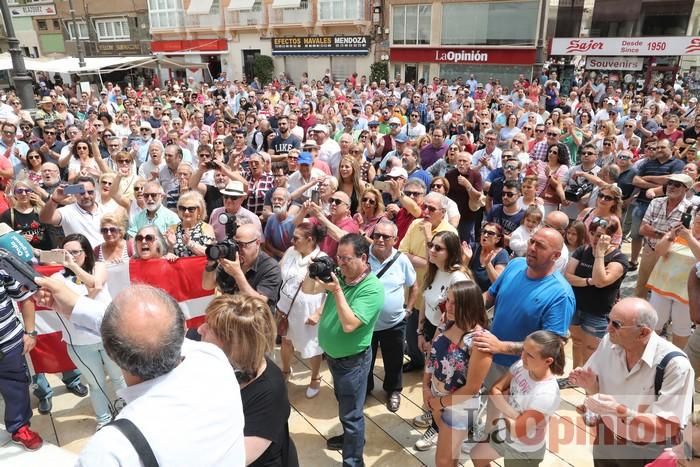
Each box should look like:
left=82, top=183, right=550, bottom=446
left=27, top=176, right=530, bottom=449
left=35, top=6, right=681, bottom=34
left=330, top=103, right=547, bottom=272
left=647, top=213, right=700, bottom=349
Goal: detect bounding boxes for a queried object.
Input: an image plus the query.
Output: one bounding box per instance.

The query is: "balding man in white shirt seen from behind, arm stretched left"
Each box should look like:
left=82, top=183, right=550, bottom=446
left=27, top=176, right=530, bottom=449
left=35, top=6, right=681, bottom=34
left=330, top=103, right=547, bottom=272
left=37, top=278, right=245, bottom=467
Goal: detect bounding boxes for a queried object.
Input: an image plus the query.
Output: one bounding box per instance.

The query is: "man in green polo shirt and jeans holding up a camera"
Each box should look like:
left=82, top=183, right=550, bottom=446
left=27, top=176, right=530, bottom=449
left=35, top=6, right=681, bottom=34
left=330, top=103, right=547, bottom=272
left=317, top=234, right=384, bottom=466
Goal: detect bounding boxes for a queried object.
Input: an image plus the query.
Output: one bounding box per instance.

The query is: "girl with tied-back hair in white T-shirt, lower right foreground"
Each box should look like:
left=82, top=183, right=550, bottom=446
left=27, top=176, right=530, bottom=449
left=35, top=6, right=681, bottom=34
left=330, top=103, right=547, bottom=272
left=470, top=331, right=566, bottom=467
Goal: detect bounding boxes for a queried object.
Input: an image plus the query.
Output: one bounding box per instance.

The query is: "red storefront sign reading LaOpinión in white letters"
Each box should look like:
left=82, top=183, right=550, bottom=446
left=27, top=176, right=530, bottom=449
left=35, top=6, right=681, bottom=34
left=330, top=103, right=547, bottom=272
left=389, top=47, right=535, bottom=65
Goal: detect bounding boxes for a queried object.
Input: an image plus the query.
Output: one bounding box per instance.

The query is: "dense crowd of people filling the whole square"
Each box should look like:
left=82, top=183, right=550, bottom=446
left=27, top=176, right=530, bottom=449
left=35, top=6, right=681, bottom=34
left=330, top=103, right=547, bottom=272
left=0, top=70, right=700, bottom=466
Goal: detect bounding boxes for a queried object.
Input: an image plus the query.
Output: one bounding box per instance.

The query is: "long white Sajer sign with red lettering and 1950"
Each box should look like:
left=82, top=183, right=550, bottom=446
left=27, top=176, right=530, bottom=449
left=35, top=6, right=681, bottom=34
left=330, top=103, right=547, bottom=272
left=551, top=36, right=700, bottom=56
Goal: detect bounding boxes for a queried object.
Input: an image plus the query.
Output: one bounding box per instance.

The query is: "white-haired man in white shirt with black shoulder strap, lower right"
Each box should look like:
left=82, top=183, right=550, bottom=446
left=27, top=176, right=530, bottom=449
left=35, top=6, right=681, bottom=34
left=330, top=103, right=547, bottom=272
left=569, top=297, right=695, bottom=467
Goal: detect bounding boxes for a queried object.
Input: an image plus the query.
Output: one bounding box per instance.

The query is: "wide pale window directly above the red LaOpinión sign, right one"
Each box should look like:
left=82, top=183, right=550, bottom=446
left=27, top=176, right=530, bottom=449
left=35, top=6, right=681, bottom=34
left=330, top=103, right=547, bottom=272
left=442, top=0, right=538, bottom=46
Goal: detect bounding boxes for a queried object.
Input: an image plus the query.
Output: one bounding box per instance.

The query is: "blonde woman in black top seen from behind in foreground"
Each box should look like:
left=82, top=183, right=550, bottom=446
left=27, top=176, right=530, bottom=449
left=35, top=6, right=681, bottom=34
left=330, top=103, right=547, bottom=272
left=198, top=294, right=299, bottom=467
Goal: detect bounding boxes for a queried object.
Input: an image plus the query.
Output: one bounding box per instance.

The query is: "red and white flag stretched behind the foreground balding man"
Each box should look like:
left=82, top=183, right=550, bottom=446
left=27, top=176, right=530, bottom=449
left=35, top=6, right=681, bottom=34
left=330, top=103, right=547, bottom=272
left=30, top=256, right=214, bottom=373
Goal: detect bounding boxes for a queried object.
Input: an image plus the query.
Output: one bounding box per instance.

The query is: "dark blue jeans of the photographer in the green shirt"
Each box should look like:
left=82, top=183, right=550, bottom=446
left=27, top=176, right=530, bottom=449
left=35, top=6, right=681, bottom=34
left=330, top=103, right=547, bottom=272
left=326, top=347, right=372, bottom=467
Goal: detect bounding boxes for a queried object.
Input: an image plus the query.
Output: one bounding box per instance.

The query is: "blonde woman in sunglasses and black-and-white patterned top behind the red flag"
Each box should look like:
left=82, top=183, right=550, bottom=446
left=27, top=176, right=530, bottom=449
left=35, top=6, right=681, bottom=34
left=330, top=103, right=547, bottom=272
left=165, top=191, right=216, bottom=261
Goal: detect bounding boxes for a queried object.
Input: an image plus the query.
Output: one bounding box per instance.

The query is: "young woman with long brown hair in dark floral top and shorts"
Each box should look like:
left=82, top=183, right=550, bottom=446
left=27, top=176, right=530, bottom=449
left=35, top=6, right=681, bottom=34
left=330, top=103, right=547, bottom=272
left=423, top=281, right=492, bottom=467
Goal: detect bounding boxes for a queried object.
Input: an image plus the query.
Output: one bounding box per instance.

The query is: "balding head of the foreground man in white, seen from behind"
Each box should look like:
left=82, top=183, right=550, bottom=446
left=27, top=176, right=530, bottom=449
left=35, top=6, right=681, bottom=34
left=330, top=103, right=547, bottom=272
left=100, top=285, right=185, bottom=381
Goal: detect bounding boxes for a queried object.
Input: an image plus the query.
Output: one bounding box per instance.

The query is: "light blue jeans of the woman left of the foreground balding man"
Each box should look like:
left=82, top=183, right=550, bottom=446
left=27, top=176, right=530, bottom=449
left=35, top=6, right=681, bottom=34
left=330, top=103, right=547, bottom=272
left=68, top=342, right=126, bottom=424
